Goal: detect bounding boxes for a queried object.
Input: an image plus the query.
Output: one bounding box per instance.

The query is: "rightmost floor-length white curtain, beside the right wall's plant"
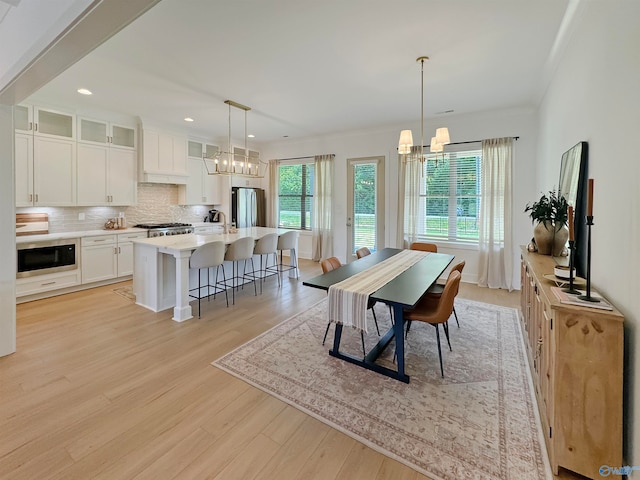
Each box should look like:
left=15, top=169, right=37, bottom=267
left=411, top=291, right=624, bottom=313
left=478, top=137, right=513, bottom=291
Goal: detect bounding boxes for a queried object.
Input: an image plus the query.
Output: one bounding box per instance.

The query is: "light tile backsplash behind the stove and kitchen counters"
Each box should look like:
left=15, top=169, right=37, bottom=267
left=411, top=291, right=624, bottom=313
left=16, top=183, right=213, bottom=233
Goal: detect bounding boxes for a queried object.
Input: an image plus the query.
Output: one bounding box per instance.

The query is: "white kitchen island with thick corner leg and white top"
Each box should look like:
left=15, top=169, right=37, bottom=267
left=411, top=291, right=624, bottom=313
left=133, top=227, right=297, bottom=322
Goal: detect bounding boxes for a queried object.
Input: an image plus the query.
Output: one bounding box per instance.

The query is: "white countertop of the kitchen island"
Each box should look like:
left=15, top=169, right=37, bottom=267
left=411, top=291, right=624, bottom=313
left=133, top=227, right=291, bottom=252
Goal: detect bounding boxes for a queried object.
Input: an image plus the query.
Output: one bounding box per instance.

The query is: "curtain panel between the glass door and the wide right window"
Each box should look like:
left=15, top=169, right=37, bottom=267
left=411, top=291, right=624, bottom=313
left=396, top=146, right=422, bottom=248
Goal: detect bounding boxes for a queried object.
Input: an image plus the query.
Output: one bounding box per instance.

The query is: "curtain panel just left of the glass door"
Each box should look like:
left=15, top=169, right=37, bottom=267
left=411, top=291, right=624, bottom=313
left=311, top=155, right=335, bottom=261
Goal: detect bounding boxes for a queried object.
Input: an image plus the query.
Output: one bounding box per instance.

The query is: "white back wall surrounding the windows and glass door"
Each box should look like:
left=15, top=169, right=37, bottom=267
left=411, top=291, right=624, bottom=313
left=261, top=107, right=536, bottom=287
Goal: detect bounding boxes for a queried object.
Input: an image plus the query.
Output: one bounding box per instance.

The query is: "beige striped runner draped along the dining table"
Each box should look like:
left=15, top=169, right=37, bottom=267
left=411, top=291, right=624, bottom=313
left=327, top=250, right=429, bottom=333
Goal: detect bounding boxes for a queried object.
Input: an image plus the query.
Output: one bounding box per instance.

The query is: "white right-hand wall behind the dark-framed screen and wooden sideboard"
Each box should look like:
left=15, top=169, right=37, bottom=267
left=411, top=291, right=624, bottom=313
left=537, top=1, right=640, bottom=465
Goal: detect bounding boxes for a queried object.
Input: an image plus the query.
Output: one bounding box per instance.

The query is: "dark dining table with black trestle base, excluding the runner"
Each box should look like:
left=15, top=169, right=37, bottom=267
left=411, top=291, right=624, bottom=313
left=302, top=248, right=454, bottom=383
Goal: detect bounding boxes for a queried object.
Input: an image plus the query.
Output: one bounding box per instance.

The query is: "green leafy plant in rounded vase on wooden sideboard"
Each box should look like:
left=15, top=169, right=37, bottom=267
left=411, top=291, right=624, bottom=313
left=524, top=190, right=569, bottom=256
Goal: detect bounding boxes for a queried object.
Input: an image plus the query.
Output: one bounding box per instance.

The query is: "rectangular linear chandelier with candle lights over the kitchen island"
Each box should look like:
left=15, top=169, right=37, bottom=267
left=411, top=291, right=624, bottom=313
left=202, top=100, right=267, bottom=178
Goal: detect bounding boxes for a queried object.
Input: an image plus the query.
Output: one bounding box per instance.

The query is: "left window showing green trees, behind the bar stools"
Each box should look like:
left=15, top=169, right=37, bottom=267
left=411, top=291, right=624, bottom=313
left=278, top=163, right=313, bottom=230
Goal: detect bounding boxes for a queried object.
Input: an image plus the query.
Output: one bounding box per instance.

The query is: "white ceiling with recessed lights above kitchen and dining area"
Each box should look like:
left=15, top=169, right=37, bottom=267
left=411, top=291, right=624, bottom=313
left=29, top=0, right=571, bottom=146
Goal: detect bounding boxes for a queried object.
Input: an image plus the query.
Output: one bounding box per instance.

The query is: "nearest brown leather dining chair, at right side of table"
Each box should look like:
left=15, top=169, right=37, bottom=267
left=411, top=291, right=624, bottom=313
left=404, top=270, right=461, bottom=378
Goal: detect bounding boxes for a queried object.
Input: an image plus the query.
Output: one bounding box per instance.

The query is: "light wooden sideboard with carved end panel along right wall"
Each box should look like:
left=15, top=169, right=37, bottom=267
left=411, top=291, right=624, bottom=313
left=521, top=248, right=624, bottom=479
